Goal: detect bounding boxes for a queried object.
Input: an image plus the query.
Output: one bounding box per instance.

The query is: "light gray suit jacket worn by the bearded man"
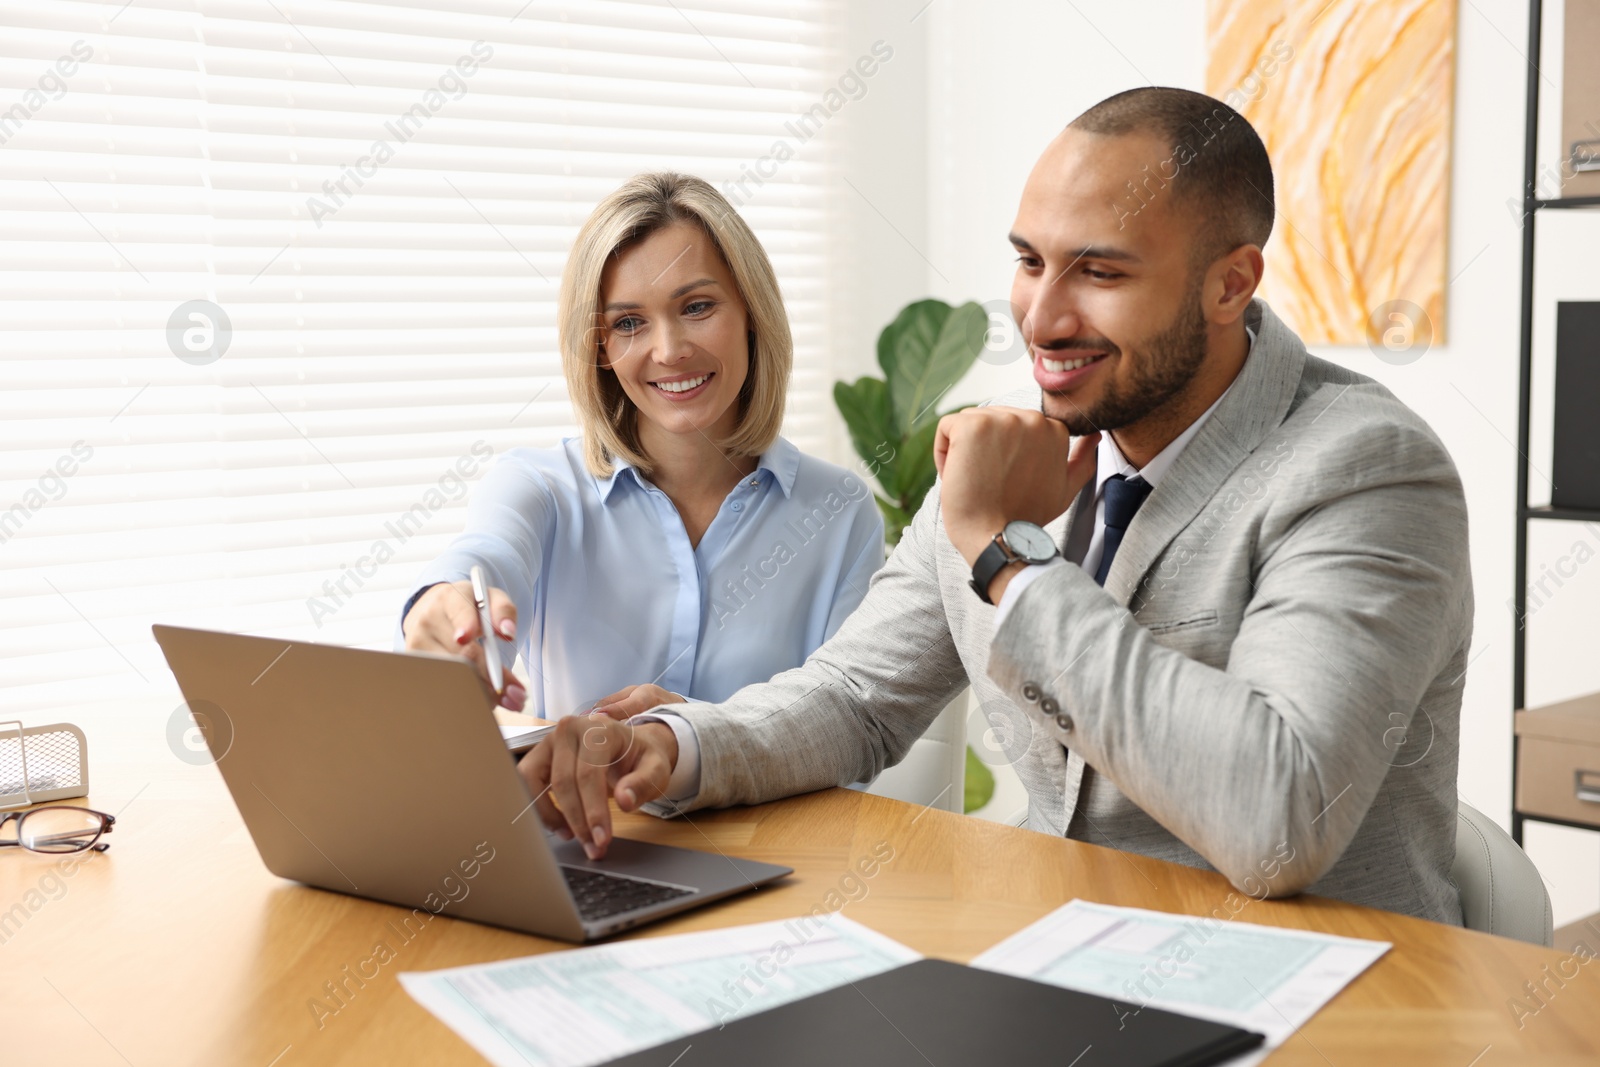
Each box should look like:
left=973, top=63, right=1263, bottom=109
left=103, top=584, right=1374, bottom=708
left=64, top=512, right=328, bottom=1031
left=670, top=301, right=1472, bottom=925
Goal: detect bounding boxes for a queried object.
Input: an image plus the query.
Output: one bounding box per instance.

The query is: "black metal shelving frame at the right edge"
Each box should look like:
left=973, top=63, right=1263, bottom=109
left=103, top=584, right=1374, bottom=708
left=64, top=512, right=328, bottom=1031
left=1510, top=0, right=1600, bottom=845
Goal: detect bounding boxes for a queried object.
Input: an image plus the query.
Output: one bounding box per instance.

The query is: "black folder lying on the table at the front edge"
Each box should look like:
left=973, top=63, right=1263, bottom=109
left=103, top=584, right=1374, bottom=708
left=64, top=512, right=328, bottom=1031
left=611, top=960, right=1264, bottom=1067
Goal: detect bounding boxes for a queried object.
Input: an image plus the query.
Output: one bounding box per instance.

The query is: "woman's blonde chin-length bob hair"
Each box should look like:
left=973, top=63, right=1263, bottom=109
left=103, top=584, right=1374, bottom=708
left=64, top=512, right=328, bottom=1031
left=557, top=171, right=794, bottom=478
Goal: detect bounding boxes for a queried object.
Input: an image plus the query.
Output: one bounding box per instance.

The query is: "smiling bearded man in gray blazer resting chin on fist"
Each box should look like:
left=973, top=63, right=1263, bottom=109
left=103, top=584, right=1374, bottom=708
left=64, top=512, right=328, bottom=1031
left=522, top=88, right=1472, bottom=925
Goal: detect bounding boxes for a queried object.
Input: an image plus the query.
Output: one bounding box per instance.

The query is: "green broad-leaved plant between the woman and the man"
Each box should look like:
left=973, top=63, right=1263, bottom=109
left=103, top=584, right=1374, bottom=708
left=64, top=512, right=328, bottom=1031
left=834, top=299, right=995, bottom=811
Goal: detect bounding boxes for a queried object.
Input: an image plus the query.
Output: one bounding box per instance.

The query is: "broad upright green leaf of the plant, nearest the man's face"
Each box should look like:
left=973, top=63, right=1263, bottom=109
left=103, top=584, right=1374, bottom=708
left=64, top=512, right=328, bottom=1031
left=878, top=299, right=989, bottom=434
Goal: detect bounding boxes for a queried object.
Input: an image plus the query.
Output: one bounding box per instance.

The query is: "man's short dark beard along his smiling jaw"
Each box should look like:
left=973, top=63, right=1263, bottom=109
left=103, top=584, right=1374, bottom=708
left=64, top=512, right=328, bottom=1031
left=1045, top=285, right=1206, bottom=437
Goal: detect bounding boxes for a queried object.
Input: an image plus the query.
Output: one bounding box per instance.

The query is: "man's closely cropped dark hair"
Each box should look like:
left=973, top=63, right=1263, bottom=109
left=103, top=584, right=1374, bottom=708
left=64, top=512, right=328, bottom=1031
left=1069, top=86, right=1274, bottom=262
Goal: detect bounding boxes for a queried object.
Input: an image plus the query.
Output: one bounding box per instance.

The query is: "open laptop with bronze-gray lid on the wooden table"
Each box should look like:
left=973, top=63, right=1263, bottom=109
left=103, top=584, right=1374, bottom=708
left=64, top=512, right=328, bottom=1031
left=150, top=625, right=794, bottom=941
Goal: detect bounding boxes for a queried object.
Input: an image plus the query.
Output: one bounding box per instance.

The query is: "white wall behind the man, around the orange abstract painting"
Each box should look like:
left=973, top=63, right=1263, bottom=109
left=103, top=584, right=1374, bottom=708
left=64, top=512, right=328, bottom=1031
left=838, top=0, right=1600, bottom=925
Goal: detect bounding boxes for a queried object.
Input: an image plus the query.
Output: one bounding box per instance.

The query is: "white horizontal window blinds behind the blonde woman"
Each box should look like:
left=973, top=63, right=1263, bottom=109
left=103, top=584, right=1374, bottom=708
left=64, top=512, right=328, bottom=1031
left=0, top=0, right=837, bottom=712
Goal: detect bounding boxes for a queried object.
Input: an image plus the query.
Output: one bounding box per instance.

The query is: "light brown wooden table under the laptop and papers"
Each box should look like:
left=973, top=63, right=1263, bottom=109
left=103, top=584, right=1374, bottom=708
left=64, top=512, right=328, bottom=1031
left=0, top=705, right=1600, bottom=1067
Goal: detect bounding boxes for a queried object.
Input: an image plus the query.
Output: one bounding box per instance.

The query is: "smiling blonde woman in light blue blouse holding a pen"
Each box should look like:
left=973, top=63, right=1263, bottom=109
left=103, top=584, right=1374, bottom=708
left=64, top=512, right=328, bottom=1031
left=398, top=173, right=883, bottom=718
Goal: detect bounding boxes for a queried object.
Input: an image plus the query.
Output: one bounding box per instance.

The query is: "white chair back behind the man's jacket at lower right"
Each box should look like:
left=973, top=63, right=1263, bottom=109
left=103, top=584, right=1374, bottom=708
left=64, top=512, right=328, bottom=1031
left=1450, top=800, right=1552, bottom=947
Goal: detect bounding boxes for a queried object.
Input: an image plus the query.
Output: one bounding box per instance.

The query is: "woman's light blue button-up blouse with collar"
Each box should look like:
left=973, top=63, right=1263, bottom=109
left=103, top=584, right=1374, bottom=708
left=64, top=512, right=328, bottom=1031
left=397, top=438, right=883, bottom=718
